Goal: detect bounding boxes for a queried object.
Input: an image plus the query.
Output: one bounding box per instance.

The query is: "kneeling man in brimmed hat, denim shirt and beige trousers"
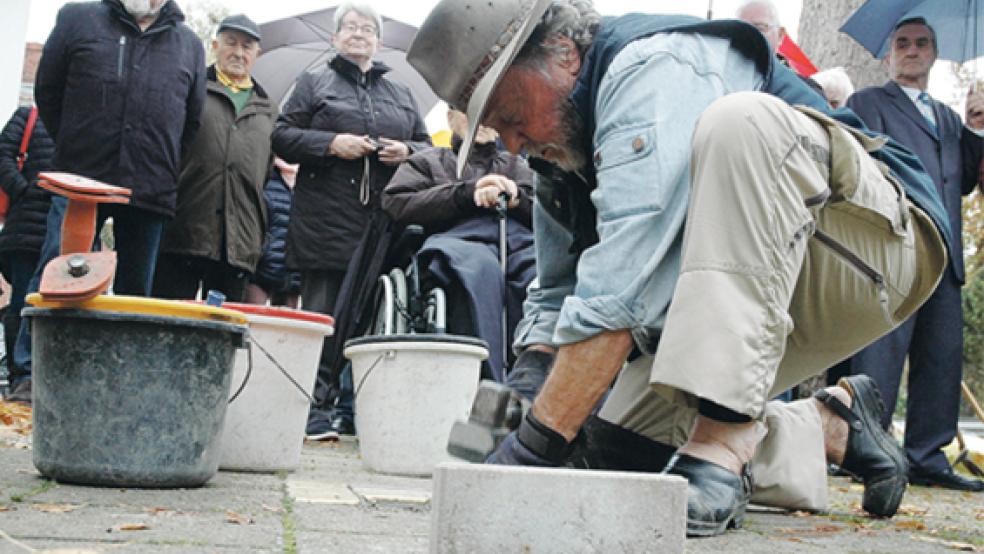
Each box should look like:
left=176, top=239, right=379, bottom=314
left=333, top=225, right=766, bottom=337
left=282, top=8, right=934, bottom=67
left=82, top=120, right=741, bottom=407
left=409, top=0, right=953, bottom=535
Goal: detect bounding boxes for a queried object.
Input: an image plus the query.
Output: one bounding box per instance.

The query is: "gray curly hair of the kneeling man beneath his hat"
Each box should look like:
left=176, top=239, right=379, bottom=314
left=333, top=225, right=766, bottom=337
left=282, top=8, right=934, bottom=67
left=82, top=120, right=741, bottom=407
left=513, top=0, right=601, bottom=72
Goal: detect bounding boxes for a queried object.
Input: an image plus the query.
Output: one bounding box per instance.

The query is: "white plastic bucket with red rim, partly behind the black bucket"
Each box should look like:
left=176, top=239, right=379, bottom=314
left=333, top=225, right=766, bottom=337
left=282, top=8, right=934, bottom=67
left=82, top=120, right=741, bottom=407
left=219, top=313, right=333, bottom=472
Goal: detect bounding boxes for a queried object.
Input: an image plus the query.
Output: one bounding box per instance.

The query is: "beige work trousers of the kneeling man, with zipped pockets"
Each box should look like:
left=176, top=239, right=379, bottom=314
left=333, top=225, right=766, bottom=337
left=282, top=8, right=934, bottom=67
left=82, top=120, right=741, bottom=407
left=599, top=92, right=946, bottom=510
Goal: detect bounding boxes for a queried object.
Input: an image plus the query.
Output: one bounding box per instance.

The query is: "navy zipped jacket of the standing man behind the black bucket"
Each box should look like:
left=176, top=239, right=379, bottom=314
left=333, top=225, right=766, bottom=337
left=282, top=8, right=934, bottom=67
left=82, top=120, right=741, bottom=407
left=34, top=0, right=205, bottom=215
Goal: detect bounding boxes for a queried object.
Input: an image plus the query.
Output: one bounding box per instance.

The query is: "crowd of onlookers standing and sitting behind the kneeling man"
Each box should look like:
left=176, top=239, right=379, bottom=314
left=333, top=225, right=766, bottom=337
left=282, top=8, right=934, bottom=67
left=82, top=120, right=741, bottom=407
left=0, top=0, right=984, bottom=490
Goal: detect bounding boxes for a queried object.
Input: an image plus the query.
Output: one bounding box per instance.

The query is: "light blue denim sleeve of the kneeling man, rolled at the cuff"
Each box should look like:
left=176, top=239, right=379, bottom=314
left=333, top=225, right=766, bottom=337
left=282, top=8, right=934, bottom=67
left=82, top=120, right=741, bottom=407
left=552, top=35, right=751, bottom=353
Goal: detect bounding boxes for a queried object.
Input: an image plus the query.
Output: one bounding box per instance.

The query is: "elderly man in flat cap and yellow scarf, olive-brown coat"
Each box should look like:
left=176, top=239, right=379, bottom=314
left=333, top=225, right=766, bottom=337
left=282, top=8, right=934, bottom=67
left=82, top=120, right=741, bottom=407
left=154, top=14, right=277, bottom=302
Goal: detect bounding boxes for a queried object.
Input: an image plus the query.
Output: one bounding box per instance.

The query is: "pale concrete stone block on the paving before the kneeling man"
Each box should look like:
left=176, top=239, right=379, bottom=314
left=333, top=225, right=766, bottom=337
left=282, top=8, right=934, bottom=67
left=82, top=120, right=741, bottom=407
left=430, top=462, right=687, bottom=554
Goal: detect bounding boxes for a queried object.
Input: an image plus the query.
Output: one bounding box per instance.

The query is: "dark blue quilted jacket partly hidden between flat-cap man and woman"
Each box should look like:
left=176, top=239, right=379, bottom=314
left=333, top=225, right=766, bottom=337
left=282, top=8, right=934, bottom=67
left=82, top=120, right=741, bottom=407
left=253, top=169, right=301, bottom=293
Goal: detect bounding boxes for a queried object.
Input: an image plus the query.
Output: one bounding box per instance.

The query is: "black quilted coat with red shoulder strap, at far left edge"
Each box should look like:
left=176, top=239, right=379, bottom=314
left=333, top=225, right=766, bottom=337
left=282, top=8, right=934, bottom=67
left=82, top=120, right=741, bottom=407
left=0, top=107, right=55, bottom=254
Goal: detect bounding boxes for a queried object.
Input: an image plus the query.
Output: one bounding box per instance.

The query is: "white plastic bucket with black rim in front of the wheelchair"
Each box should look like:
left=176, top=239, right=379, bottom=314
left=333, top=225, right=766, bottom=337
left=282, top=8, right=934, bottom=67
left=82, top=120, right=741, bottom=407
left=345, top=335, right=489, bottom=476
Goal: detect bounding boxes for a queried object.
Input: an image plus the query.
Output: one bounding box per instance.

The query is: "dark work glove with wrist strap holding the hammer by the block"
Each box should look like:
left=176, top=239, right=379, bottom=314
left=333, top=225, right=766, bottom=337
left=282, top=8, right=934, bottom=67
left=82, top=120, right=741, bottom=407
left=485, top=410, right=580, bottom=467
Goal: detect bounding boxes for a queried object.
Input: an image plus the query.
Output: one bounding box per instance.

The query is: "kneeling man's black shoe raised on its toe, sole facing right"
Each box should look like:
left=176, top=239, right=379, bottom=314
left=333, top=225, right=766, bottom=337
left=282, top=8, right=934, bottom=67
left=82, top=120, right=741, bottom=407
left=814, top=375, right=909, bottom=517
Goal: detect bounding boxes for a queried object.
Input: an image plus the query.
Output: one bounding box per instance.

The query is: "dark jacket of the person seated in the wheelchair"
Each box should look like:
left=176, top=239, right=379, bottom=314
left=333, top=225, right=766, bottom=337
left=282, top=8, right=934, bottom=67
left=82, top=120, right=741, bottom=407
left=383, top=136, right=534, bottom=234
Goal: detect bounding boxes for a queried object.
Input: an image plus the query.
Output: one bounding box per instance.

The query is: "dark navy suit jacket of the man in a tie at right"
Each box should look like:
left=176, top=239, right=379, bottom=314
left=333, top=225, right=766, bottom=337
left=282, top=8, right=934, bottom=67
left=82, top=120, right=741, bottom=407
left=847, top=81, right=984, bottom=283
